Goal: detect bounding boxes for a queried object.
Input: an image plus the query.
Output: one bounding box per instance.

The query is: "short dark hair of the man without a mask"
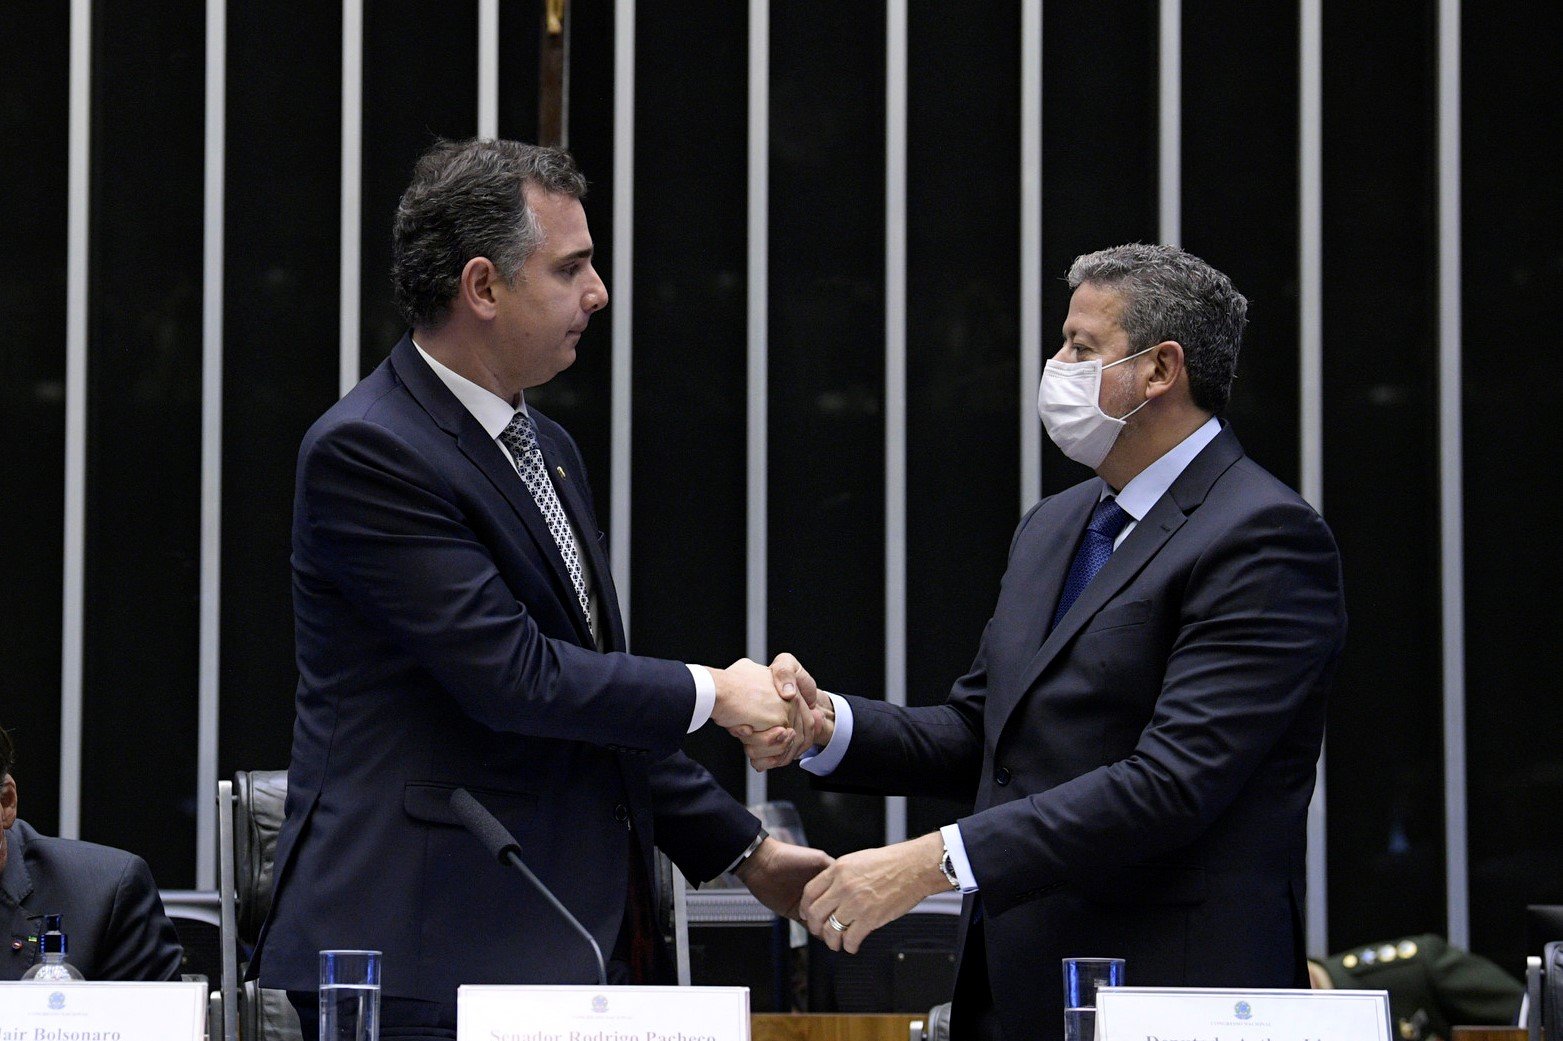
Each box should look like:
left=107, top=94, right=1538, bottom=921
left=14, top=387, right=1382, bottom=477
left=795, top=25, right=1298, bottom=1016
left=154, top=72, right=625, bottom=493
left=391, top=138, right=586, bottom=327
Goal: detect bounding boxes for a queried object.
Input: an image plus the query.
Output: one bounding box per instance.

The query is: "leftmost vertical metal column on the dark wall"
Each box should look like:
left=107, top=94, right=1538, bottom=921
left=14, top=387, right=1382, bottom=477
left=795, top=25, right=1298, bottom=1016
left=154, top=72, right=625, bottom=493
left=59, top=0, right=92, bottom=838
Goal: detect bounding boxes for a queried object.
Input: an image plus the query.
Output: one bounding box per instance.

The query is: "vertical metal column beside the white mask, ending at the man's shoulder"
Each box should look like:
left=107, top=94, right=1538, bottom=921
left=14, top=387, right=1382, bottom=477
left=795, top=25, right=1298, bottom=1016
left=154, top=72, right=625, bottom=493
left=1021, top=0, right=1043, bottom=513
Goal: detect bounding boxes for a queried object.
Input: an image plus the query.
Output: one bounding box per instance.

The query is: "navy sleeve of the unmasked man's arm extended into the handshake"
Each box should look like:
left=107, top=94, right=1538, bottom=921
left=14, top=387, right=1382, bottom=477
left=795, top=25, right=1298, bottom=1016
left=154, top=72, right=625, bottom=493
left=295, top=420, right=694, bottom=755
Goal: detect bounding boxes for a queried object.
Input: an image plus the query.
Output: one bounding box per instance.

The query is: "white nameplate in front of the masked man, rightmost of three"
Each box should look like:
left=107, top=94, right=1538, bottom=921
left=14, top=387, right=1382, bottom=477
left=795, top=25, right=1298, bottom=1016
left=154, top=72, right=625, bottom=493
left=1096, top=986, right=1390, bottom=1041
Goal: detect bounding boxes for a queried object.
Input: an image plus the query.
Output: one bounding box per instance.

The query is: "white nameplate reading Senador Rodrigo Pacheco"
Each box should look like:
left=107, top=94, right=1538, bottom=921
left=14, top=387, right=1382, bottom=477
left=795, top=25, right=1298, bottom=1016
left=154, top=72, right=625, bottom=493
left=456, top=985, right=749, bottom=1041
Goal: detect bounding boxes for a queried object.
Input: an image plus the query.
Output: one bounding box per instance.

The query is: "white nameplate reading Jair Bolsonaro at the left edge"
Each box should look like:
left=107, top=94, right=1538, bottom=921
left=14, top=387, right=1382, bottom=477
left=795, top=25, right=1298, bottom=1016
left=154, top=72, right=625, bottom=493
left=0, top=980, right=206, bottom=1041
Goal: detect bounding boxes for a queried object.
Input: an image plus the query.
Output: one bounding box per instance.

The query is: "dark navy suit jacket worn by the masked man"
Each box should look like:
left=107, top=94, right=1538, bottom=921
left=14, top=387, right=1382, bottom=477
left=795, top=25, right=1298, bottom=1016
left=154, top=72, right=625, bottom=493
left=821, top=430, right=1346, bottom=1038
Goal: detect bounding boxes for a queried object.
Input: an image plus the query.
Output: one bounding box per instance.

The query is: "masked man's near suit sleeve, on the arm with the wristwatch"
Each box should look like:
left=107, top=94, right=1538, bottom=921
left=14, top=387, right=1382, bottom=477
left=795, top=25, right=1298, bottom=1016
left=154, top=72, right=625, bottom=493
left=960, top=502, right=1346, bottom=913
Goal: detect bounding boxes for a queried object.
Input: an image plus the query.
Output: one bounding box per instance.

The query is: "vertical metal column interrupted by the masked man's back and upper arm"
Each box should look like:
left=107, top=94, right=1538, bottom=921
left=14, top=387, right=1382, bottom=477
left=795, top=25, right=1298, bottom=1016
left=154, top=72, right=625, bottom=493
left=1297, top=0, right=1330, bottom=958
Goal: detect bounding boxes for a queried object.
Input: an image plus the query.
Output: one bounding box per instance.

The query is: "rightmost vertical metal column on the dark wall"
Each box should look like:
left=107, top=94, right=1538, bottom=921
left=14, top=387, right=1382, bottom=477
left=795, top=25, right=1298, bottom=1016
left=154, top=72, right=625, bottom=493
left=1438, top=0, right=1471, bottom=947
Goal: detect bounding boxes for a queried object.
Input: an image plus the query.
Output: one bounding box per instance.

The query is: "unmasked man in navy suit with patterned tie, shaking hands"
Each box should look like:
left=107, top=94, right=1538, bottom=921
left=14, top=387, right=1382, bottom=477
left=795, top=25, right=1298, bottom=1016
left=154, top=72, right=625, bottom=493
left=258, top=141, right=830, bottom=1038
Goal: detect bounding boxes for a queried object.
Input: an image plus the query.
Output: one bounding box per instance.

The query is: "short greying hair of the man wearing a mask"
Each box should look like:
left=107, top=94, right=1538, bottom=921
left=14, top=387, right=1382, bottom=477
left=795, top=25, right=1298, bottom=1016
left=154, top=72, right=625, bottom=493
left=1069, top=242, right=1249, bottom=416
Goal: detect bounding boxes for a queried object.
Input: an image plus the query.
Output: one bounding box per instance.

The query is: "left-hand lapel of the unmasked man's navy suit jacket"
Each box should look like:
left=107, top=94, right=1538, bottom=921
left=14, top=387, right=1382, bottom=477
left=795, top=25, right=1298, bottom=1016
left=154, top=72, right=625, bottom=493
left=391, top=336, right=594, bottom=647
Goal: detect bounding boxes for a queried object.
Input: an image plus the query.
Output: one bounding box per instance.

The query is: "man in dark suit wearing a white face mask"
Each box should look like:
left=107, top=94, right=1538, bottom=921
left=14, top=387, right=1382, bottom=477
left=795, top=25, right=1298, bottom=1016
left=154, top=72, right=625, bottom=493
left=750, top=245, right=1346, bottom=1038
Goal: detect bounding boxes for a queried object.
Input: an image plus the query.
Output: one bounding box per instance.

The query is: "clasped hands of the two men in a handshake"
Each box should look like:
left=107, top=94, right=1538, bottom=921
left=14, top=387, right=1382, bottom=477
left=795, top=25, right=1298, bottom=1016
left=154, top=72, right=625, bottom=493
left=708, top=653, right=835, bottom=771
